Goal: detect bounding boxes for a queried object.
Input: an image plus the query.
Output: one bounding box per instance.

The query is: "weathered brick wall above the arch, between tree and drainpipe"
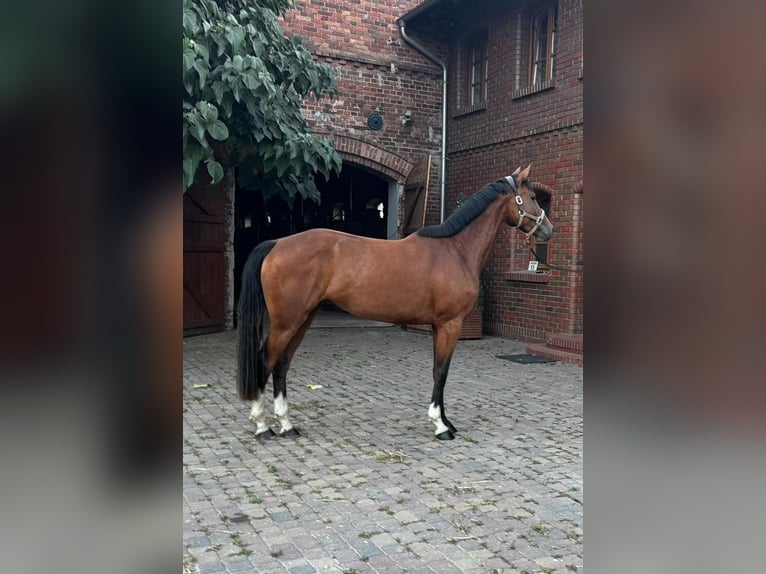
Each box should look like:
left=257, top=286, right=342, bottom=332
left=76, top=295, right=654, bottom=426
left=283, top=0, right=446, bottom=200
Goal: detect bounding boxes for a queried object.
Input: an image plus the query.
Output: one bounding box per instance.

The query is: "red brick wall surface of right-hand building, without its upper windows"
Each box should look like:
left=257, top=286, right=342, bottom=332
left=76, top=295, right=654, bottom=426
left=447, top=0, right=583, bottom=340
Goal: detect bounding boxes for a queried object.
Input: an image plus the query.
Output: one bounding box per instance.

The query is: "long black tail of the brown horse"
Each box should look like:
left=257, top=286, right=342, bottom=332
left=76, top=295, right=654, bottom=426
left=237, top=241, right=276, bottom=401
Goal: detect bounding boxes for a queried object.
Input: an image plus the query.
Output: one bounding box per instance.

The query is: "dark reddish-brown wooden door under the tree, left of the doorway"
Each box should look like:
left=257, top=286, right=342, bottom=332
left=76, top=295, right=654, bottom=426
left=184, top=181, right=226, bottom=336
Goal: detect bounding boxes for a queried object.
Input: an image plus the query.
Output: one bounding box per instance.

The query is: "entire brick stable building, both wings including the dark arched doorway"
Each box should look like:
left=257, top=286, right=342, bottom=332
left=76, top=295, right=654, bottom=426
left=184, top=0, right=583, bottom=356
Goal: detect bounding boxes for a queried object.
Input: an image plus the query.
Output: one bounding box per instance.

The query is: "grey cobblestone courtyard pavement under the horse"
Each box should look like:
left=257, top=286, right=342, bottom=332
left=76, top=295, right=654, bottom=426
left=183, top=314, right=582, bottom=574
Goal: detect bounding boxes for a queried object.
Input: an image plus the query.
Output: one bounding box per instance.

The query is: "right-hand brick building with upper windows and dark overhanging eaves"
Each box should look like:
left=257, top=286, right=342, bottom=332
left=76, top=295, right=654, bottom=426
left=403, top=0, right=583, bottom=359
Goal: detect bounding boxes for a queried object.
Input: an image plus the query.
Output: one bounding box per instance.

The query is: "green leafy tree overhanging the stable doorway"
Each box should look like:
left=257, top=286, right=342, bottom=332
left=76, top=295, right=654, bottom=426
left=183, top=0, right=341, bottom=204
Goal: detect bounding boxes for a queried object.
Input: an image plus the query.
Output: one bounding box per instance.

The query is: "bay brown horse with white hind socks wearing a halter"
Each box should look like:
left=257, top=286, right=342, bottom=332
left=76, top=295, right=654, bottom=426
left=237, top=167, right=553, bottom=439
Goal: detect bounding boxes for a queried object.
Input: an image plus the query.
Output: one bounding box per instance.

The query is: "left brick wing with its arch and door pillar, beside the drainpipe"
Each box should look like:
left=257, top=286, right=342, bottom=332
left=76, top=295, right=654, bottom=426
left=283, top=0, right=446, bottom=239
